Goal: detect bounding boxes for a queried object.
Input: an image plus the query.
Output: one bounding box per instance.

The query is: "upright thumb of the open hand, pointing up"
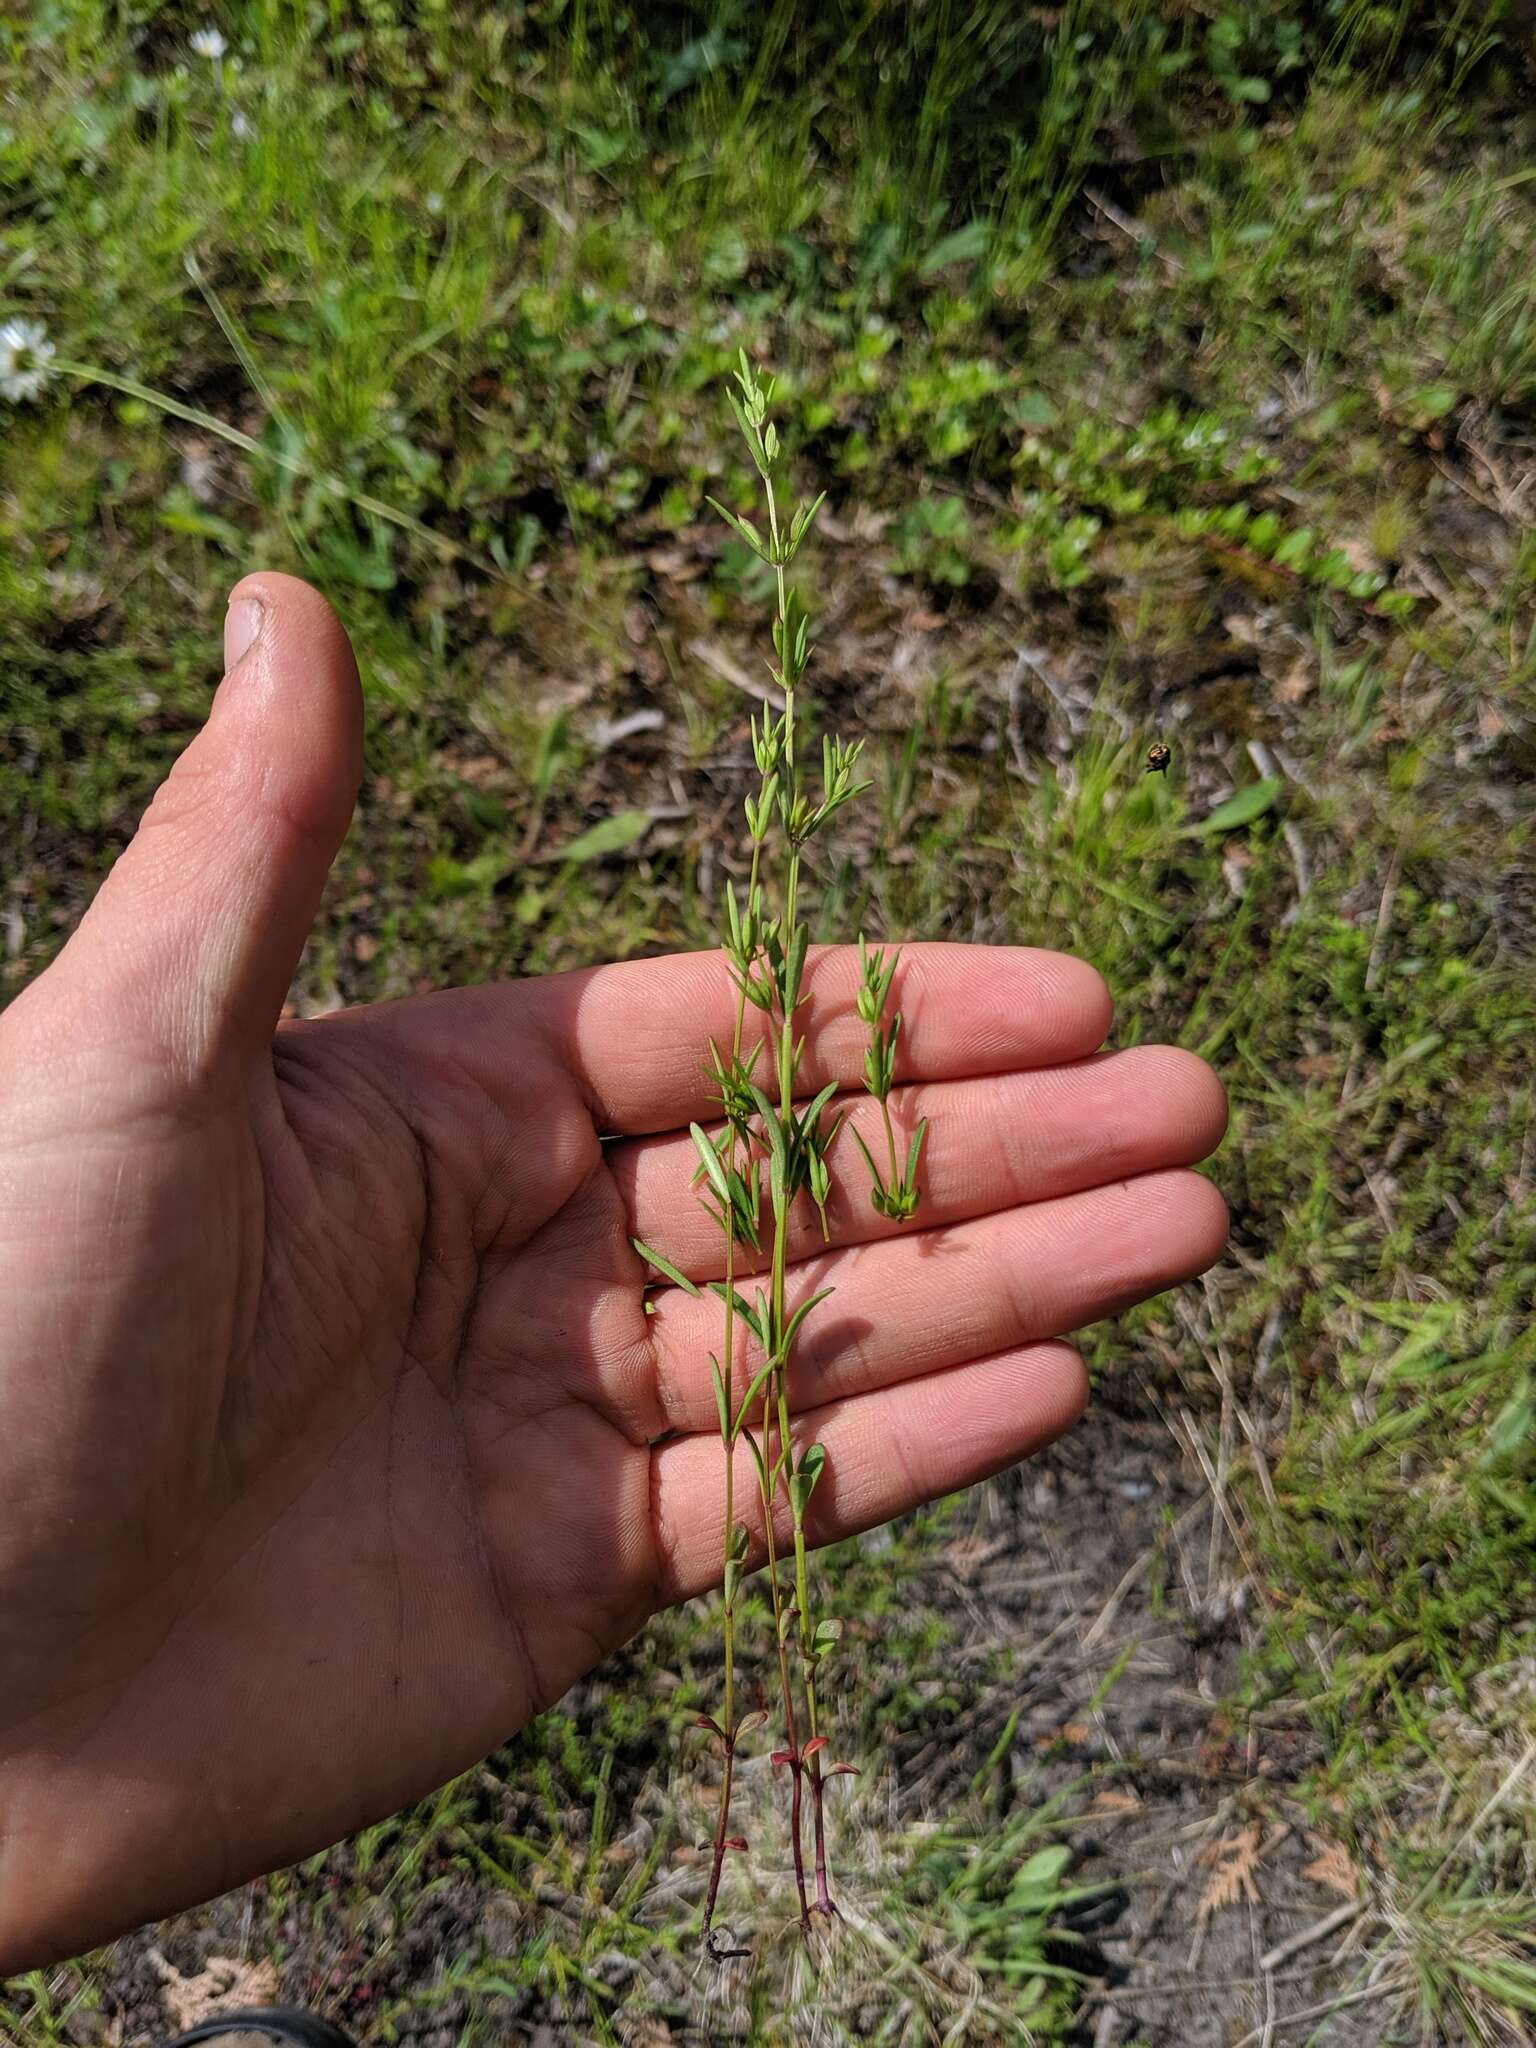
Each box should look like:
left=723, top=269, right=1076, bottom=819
left=39, top=571, right=362, bottom=1079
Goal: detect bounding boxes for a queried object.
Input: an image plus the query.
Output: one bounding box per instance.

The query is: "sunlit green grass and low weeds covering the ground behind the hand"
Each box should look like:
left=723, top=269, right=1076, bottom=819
left=0, top=0, right=1536, bottom=2042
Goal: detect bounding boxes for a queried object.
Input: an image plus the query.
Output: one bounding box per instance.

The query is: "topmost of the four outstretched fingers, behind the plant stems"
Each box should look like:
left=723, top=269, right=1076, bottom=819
left=530, top=944, right=1112, bottom=1137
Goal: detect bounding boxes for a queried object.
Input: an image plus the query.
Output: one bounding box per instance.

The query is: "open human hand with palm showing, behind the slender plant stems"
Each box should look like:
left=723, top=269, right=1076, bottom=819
left=0, top=575, right=1225, bottom=1970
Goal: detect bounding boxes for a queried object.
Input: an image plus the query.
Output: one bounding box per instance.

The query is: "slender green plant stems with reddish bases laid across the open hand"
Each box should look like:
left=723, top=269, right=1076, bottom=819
left=637, top=354, right=928, bottom=1956
